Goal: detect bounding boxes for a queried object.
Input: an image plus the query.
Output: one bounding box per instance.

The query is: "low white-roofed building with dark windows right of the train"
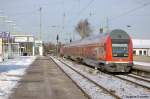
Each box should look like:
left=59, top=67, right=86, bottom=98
left=132, top=39, right=150, bottom=56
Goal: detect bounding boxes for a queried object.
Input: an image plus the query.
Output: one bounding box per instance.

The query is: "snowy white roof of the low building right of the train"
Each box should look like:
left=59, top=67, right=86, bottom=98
left=132, top=39, right=150, bottom=48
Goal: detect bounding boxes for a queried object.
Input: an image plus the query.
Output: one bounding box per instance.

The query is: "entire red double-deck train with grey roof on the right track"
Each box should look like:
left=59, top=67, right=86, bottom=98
left=60, top=29, right=133, bottom=72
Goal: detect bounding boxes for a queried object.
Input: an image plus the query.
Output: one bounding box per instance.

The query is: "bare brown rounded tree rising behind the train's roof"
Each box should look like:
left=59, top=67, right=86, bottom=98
left=75, top=19, right=92, bottom=39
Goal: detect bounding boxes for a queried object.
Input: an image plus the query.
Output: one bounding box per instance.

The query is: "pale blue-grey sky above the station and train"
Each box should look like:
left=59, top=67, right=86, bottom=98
left=0, top=0, right=150, bottom=42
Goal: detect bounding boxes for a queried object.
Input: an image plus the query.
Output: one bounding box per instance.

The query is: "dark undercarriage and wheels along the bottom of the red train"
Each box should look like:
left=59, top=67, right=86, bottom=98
left=67, top=56, right=133, bottom=73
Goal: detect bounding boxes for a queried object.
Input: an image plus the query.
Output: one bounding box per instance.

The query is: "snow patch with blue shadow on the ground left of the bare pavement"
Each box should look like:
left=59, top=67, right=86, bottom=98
left=0, top=56, right=36, bottom=99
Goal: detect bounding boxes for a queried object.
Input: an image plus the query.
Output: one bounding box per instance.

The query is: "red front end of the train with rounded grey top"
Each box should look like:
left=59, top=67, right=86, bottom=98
left=103, top=29, right=133, bottom=72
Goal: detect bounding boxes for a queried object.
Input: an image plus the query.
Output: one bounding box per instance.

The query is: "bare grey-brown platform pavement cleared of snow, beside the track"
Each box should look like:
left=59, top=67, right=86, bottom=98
left=9, top=57, right=87, bottom=99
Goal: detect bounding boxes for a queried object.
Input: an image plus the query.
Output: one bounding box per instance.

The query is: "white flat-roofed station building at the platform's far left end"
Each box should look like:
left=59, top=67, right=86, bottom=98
left=13, top=35, right=43, bottom=56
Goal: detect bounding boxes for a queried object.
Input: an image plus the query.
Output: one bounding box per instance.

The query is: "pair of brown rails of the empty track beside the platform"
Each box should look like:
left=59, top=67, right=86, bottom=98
left=52, top=58, right=121, bottom=99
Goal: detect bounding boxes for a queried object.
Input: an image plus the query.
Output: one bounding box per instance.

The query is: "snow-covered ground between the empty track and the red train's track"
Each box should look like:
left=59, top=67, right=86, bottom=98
left=58, top=57, right=150, bottom=98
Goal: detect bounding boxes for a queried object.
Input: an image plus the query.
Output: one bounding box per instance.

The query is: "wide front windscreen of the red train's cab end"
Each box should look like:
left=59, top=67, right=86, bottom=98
left=112, top=44, right=128, bottom=57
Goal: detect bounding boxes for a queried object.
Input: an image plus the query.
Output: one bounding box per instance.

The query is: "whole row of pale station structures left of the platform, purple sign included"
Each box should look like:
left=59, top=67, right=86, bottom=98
left=0, top=32, right=43, bottom=62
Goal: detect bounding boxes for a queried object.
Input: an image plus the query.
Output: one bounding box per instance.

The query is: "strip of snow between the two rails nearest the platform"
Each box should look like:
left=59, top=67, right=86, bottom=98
left=51, top=57, right=114, bottom=99
